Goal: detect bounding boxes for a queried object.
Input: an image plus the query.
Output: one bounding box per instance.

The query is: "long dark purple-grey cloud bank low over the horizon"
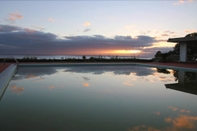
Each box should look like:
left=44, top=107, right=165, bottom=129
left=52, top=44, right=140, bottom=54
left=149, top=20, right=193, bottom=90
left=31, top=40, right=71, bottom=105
left=0, top=25, right=163, bottom=56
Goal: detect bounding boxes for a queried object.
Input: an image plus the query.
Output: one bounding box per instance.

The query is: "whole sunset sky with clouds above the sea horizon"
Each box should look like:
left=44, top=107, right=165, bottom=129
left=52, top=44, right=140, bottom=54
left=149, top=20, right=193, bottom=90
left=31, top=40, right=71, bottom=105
left=0, top=0, right=197, bottom=57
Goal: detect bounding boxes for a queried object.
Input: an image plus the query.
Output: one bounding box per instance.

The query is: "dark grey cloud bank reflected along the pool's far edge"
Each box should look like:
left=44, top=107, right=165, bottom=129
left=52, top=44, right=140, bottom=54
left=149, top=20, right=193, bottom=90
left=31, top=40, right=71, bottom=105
left=13, top=66, right=156, bottom=81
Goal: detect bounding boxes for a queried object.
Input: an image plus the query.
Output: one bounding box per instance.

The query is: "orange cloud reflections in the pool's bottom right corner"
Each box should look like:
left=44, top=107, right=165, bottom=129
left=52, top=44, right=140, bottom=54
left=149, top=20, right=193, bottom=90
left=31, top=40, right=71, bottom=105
left=128, top=106, right=197, bottom=131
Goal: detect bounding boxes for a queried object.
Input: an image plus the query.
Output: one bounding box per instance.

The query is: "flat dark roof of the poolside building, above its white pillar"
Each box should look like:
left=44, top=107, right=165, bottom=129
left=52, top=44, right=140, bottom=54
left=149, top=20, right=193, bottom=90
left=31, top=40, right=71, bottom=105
left=167, top=36, right=197, bottom=44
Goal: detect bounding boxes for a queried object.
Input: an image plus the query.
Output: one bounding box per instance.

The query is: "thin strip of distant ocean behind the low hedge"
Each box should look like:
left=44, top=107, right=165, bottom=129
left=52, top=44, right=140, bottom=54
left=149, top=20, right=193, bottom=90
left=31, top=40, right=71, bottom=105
left=0, top=55, right=151, bottom=60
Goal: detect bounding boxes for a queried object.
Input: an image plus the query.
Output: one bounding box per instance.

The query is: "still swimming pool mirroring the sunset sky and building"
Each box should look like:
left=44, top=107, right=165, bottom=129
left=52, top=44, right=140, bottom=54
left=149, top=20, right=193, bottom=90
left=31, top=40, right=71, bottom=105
left=0, top=65, right=197, bottom=131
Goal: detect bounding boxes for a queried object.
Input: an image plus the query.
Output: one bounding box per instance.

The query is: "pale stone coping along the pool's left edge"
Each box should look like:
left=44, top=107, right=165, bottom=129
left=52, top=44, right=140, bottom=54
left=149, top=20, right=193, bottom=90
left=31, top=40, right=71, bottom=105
left=0, top=64, right=17, bottom=100
